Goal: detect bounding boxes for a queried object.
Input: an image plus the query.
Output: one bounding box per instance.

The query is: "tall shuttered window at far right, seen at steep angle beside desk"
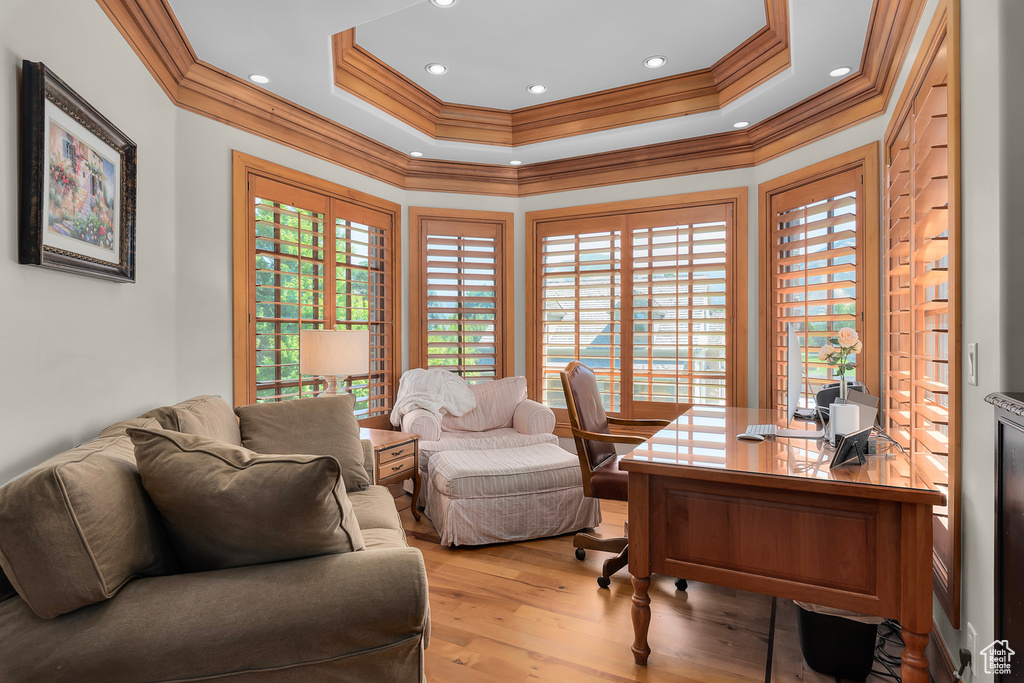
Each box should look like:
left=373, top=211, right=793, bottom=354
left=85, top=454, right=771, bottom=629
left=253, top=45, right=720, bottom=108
left=883, top=3, right=958, bottom=628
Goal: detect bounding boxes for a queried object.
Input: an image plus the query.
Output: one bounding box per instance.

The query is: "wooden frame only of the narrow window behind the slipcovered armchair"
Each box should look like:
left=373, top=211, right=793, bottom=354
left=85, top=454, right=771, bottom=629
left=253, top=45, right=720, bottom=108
left=409, top=207, right=515, bottom=379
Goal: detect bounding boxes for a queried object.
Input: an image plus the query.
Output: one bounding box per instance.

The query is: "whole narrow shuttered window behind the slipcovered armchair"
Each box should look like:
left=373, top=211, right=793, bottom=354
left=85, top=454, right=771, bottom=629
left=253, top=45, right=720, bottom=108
left=410, top=208, right=515, bottom=382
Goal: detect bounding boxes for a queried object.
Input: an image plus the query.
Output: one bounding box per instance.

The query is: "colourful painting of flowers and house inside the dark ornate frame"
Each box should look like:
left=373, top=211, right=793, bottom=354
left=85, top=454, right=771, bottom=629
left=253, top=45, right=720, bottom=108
left=46, top=121, right=117, bottom=252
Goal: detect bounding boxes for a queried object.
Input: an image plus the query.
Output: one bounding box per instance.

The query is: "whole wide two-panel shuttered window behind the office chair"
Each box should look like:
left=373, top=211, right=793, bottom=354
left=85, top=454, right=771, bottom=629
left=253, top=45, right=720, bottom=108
left=526, top=188, right=746, bottom=422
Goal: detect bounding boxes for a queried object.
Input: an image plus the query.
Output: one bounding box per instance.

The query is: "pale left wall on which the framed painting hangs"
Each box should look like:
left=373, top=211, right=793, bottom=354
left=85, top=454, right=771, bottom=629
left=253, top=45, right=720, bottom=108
left=0, top=0, right=177, bottom=482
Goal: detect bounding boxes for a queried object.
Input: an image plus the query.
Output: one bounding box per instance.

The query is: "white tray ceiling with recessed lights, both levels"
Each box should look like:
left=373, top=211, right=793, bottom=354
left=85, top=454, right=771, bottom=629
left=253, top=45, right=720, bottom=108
left=168, top=0, right=871, bottom=164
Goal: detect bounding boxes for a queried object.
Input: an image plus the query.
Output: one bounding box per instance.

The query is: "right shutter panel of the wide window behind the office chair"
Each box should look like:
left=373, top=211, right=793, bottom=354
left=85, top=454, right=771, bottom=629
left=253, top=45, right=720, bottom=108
left=623, top=205, right=731, bottom=415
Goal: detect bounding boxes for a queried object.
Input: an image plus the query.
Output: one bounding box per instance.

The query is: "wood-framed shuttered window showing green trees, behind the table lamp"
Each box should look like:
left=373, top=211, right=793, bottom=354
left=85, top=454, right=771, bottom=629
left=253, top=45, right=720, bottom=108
left=233, top=153, right=398, bottom=426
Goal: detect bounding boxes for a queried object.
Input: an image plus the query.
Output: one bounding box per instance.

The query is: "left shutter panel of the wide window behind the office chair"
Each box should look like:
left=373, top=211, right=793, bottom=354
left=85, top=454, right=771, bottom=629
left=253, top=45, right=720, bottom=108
left=538, top=216, right=625, bottom=413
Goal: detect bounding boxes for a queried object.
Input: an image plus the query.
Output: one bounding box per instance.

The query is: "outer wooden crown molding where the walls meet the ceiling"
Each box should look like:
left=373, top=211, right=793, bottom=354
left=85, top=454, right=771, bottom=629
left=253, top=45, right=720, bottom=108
left=97, top=0, right=925, bottom=197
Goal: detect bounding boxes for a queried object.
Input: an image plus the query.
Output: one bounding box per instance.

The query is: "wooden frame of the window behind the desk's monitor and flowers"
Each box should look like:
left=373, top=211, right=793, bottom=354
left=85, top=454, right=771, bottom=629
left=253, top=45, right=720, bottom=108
left=758, top=142, right=882, bottom=409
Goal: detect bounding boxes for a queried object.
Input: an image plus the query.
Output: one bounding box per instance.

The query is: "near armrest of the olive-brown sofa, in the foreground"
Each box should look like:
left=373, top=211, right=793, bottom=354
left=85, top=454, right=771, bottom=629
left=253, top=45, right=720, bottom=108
left=0, top=548, right=429, bottom=683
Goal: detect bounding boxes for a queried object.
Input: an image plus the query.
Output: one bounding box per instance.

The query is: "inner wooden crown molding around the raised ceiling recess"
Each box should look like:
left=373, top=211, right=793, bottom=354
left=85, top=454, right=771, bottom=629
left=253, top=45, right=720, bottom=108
left=333, top=0, right=790, bottom=146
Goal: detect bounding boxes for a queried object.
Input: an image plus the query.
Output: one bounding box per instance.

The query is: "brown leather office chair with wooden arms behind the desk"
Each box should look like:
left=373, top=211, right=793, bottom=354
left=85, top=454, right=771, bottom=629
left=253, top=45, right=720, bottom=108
left=560, top=360, right=686, bottom=591
